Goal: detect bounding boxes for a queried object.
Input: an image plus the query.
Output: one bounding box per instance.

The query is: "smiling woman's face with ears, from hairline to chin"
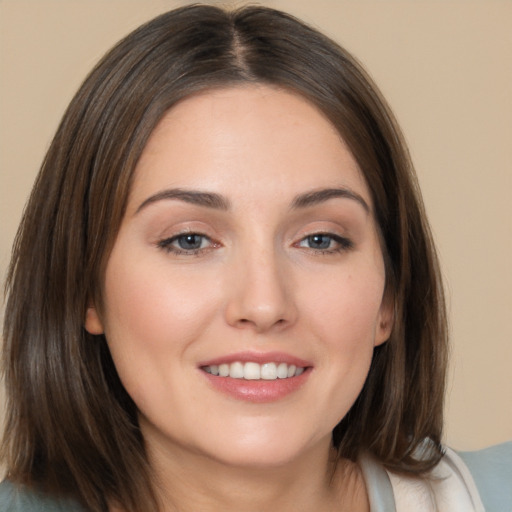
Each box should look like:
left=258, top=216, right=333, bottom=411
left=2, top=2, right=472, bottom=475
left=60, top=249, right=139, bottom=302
left=86, top=86, right=392, bottom=466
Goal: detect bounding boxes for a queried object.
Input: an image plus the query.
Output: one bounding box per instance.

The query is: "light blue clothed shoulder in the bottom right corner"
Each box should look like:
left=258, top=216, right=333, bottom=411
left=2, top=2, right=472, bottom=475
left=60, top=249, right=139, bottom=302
left=457, top=441, right=512, bottom=512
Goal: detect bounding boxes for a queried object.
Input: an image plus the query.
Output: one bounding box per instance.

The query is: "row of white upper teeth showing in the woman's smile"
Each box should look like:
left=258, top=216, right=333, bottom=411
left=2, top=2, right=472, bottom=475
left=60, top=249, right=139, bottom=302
left=203, top=361, right=305, bottom=380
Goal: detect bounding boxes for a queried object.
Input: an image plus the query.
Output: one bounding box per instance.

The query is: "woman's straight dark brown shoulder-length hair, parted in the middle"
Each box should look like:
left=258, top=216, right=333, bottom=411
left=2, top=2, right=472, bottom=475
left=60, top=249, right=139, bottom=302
left=2, top=6, right=447, bottom=512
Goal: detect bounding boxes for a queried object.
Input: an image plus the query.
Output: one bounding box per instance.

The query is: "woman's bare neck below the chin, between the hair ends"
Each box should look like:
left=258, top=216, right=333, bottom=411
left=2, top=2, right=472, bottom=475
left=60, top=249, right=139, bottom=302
left=144, top=436, right=369, bottom=512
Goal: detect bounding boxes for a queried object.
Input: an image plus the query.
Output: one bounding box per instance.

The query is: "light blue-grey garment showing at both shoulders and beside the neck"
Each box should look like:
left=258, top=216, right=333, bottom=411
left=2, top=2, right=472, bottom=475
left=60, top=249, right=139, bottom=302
left=0, top=442, right=512, bottom=512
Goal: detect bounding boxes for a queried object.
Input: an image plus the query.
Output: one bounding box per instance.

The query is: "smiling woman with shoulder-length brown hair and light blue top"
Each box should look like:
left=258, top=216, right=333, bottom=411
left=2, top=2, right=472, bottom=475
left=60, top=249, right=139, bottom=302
left=0, top=6, right=506, bottom=512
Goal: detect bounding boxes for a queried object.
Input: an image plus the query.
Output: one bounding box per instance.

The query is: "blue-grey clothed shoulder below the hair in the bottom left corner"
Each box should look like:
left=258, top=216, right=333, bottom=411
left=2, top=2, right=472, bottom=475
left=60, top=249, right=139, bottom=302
left=0, top=480, right=83, bottom=512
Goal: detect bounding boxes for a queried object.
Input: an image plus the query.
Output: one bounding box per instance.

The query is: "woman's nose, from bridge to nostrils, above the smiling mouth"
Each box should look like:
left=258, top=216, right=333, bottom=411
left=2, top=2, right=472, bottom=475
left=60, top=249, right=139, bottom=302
left=226, top=249, right=297, bottom=333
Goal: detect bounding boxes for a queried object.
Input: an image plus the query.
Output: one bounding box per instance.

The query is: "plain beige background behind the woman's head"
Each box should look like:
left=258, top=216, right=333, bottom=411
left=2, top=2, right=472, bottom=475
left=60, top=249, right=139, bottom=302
left=0, top=0, right=512, bottom=449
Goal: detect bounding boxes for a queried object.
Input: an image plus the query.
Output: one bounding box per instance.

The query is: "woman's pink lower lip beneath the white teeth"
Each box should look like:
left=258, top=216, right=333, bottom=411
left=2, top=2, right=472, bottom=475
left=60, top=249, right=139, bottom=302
left=201, top=368, right=311, bottom=403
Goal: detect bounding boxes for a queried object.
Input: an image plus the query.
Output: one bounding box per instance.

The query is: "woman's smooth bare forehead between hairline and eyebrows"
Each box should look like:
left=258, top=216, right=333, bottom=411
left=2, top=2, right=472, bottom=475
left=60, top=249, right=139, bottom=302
left=127, top=85, right=371, bottom=210
